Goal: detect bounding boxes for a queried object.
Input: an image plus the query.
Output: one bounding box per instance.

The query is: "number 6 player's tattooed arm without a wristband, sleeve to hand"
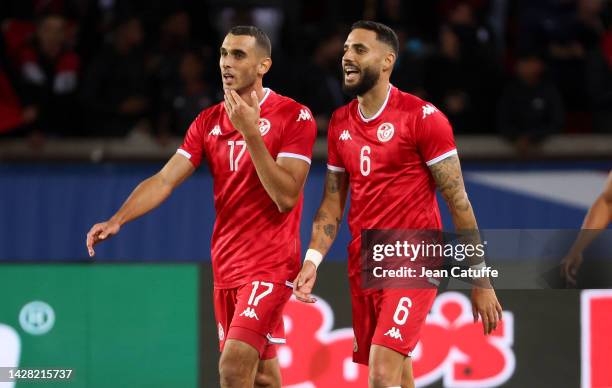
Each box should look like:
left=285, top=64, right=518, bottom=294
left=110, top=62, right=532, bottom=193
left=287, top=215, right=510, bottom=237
left=429, top=155, right=502, bottom=335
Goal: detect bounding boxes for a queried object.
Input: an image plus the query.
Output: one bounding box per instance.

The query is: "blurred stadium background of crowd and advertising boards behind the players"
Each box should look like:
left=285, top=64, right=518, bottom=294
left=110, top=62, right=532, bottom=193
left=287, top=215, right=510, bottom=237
left=0, top=0, right=612, bottom=388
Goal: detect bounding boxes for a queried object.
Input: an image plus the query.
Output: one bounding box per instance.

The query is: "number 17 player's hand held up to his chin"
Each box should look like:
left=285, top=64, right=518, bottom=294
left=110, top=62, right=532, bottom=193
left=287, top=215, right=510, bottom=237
left=224, top=89, right=261, bottom=139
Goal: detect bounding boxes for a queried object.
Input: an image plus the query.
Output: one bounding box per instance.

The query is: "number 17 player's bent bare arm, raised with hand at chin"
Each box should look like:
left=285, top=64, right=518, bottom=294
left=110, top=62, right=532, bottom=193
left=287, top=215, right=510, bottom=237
left=225, top=90, right=310, bottom=213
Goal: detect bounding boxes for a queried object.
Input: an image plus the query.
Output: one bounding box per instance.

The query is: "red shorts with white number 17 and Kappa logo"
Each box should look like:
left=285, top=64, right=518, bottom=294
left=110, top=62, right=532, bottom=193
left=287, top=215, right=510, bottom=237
left=214, top=281, right=292, bottom=360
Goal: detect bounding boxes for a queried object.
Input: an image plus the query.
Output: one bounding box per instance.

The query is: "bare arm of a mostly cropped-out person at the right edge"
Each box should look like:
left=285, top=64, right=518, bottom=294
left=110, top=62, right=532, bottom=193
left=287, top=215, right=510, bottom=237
left=561, top=171, right=612, bottom=287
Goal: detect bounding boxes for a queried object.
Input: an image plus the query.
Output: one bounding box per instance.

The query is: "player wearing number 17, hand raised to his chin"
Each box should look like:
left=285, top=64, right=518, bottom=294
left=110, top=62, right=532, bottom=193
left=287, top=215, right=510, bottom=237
left=87, top=26, right=316, bottom=388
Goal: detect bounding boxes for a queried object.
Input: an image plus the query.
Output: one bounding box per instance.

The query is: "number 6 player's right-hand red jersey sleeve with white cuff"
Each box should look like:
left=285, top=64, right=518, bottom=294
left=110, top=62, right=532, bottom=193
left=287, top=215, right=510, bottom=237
left=415, top=104, right=457, bottom=166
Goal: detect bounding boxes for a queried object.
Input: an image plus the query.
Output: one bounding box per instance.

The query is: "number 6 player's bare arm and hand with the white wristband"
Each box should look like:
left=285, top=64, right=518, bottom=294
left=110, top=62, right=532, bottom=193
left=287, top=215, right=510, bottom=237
left=293, top=170, right=349, bottom=303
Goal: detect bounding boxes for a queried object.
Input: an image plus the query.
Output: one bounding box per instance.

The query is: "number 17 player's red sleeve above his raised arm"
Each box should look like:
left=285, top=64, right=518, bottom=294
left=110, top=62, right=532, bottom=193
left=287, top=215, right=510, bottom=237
left=277, top=105, right=317, bottom=164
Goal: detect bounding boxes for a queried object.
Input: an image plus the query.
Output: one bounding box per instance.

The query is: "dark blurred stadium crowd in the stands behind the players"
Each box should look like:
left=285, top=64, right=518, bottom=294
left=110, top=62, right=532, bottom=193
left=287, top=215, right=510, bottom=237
left=0, top=0, right=612, bottom=147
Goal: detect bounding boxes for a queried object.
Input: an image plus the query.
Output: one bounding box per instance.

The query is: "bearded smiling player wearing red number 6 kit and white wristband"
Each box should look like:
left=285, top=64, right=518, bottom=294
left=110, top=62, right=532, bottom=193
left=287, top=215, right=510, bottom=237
left=294, top=21, right=502, bottom=387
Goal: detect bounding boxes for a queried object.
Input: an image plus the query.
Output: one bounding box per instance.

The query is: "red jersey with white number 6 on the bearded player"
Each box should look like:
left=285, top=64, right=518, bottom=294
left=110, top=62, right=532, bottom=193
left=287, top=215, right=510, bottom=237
left=327, top=86, right=457, bottom=294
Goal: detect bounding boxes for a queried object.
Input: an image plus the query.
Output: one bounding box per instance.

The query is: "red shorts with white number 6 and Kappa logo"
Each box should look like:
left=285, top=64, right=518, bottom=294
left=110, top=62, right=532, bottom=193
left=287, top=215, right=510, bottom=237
left=351, top=288, right=437, bottom=365
